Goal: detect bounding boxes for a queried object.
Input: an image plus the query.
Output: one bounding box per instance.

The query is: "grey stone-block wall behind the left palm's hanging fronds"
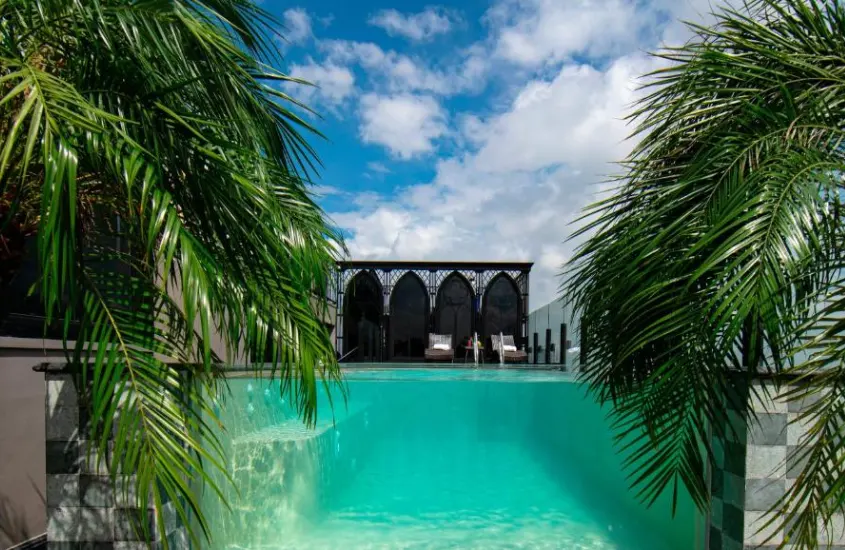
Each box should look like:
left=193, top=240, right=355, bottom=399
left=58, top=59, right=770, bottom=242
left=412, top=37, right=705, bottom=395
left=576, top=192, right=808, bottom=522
left=45, top=372, right=189, bottom=550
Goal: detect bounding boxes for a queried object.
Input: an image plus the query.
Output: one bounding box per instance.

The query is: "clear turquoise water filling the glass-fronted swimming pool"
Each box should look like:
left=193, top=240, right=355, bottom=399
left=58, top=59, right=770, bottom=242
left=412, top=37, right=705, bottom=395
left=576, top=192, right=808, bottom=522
left=202, top=368, right=703, bottom=550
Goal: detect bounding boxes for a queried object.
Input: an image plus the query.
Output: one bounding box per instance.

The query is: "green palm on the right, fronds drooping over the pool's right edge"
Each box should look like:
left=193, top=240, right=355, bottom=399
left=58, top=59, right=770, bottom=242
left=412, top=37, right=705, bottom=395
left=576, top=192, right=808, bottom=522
left=567, top=0, right=845, bottom=548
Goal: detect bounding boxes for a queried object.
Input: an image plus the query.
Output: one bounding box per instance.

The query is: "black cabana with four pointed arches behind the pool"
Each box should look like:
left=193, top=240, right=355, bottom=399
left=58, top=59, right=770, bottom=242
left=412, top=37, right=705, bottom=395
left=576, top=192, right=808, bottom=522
left=334, top=261, right=533, bottom=362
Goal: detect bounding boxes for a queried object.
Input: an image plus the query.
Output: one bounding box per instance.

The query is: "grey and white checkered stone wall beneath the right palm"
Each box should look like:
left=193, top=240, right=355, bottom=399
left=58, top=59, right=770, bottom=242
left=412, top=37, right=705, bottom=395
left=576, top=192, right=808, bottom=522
left=708, top=381, right=845, bottom=550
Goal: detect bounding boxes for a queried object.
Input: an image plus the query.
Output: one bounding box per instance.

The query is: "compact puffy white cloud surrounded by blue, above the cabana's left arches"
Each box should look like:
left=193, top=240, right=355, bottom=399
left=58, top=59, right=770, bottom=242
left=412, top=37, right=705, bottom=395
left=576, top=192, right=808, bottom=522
left=360, top=94, right=447, bottom=159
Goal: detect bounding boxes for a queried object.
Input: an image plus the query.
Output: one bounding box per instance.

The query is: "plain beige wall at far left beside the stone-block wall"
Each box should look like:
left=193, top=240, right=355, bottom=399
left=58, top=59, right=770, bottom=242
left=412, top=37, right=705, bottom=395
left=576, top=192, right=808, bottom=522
left=0, top=337, right=64, bottom=549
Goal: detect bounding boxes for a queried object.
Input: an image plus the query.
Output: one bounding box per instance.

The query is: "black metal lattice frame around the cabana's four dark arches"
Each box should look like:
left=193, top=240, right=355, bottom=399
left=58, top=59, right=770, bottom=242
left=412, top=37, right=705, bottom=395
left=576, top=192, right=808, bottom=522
left=329, top=260, right=534, bottom=361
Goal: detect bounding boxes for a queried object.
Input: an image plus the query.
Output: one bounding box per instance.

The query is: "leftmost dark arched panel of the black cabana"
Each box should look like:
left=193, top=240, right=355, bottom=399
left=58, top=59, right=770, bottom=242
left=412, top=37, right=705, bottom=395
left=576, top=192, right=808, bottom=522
left=343, top=271, right=382, bottom=361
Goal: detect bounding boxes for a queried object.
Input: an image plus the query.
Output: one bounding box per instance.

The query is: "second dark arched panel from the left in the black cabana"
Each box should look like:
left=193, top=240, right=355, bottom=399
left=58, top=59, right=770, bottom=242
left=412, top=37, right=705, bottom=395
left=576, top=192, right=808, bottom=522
left=389, top=272, right=429, bottom=361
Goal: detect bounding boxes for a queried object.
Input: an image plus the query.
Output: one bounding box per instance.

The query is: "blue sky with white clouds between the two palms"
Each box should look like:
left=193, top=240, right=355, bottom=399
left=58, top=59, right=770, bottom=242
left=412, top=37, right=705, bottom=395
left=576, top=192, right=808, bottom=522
left=263, top=0, right=711, bottom=309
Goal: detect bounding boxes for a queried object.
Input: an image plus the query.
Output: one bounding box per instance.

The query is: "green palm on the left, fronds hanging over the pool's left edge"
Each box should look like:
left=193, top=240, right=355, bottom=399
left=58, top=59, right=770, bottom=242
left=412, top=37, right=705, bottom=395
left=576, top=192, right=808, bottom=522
left=0, top=0, right=342, bottom=543
